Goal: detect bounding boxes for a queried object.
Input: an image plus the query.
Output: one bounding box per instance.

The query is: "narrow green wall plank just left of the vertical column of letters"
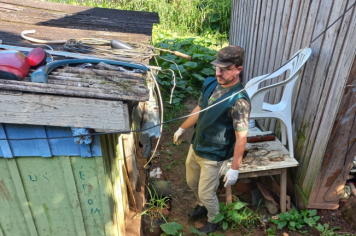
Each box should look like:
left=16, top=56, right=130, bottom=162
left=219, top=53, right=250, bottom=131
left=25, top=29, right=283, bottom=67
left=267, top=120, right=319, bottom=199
left=60, top=156, right=87, bottom=236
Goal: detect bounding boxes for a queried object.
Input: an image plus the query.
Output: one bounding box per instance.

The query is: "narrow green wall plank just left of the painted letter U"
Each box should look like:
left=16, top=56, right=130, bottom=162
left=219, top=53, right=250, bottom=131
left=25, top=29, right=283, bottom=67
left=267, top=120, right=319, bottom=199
left=7, top=159, right=38, bottom=236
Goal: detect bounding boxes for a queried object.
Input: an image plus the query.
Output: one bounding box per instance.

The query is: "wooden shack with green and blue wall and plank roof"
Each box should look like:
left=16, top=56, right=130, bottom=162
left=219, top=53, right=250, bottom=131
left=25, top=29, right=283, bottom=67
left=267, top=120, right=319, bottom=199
left=0, top=0, right=158, bottom=236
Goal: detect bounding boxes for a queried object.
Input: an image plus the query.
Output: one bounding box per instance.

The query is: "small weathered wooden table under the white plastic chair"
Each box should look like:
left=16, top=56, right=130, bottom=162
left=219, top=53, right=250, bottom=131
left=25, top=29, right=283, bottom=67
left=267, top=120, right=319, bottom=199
left=222, top=139, right=298, bottom=213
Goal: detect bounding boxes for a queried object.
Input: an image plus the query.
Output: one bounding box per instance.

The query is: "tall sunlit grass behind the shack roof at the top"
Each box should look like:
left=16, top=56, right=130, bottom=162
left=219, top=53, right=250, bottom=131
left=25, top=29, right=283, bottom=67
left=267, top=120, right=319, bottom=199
left=43, top=0, right=231, bottom=39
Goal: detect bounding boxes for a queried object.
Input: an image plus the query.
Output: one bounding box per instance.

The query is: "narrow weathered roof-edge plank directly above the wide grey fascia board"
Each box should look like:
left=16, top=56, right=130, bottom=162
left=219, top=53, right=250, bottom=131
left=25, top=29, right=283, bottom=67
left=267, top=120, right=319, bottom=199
left=0, top=79, right=148, bottom=101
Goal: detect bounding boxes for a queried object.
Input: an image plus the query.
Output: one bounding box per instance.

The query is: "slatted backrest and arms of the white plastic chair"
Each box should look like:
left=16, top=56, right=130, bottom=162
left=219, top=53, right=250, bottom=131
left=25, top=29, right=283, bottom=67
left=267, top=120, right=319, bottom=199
left=245, top=48, right=311, bottom=110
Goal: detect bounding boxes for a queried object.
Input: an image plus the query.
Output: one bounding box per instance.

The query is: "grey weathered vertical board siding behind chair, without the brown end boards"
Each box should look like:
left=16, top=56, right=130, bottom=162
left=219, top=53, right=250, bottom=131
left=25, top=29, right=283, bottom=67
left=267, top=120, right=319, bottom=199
left=230, top=0, right=356, bottom=206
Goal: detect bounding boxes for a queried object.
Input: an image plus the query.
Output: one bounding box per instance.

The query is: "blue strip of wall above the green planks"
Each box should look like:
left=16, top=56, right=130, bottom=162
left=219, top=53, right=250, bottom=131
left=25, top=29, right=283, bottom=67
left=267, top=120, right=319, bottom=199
left=0, top=124, right=102, bottom=158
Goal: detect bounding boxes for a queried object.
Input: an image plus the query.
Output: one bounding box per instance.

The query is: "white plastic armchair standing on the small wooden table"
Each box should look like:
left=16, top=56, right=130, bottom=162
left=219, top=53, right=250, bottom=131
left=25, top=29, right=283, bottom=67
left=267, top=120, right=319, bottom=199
left=245, top=48, right=311, bottom=157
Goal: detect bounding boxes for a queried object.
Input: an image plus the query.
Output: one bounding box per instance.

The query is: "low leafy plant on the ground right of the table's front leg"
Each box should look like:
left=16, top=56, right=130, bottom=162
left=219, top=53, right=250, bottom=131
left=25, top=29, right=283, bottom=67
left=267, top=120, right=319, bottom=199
left=270, top=208, right=320, bottom=231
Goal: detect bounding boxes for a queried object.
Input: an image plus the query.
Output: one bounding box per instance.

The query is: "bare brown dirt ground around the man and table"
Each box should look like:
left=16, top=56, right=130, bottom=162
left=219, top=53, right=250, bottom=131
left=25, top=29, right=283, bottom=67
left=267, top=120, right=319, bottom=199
left=134, top=99, right=356, bottom=236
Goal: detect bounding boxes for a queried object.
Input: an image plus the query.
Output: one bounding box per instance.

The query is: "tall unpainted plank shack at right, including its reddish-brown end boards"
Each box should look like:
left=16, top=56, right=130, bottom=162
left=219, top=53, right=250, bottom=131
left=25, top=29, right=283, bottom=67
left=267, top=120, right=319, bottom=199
left=230, top=0, right=356, bottom=209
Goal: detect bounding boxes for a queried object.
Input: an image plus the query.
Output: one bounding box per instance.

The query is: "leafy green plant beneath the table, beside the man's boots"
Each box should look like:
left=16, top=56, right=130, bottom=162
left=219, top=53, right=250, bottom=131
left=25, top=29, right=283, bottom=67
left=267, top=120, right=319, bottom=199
left=214, top=201, right=261, bottom=230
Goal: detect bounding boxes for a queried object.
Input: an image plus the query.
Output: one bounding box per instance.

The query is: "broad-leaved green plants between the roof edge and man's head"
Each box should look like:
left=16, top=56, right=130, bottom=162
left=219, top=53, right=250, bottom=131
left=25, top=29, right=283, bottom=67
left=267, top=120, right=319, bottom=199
left=151, top=34, right=221, bottom=109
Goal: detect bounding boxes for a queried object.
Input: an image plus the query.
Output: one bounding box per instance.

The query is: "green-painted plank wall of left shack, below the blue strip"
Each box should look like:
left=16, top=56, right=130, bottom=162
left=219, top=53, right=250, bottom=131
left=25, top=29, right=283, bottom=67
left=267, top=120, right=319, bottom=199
left=0, top=132, right=129, bottom=236
